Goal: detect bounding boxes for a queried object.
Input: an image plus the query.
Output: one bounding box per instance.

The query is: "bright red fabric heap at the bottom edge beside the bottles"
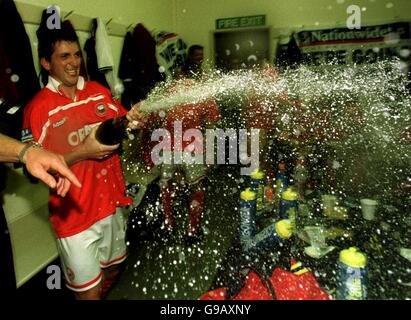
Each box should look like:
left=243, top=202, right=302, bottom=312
left=200, top=262, right=332, bottom=300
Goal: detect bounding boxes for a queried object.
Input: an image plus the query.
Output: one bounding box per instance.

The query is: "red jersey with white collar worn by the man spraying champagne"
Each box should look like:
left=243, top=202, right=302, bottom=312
left=22, top=77, right=132, bottom=238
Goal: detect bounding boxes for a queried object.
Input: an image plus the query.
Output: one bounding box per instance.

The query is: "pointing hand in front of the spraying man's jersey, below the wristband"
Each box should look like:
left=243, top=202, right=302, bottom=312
left=24, top=148, right=81, bottom=197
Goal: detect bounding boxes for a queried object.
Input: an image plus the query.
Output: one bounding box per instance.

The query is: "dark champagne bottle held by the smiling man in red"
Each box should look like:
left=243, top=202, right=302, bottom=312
left=96, top=116, right=128, bottom=146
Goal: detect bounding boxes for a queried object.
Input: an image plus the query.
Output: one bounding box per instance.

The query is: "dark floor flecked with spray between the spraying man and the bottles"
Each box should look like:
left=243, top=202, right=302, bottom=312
left=108, top=166, right=244, bottom=300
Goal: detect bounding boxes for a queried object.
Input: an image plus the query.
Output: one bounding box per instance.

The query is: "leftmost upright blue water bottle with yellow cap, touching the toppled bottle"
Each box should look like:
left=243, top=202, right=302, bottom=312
left=240, top=188, right=256, bottom=244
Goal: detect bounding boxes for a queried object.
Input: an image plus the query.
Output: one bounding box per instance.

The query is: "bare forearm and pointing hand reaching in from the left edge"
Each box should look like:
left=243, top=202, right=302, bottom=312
left=0, top=134, right=81, bottom=196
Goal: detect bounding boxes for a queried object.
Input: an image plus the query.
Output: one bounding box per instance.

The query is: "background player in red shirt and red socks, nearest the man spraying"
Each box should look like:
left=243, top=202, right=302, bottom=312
left=152, top=80, right=220, bottom=243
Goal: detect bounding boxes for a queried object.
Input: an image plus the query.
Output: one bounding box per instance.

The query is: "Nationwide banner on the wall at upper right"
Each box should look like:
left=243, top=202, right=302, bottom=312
left=294, top=22, right=411, bottom=66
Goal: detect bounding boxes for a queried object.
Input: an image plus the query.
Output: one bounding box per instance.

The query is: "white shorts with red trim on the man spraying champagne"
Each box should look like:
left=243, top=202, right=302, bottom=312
left=57, top=208, right=127, bottom=292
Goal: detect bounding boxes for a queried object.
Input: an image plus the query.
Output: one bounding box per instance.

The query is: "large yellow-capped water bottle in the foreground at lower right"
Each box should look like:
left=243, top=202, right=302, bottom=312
left=336, top=247, right=367, bottom=300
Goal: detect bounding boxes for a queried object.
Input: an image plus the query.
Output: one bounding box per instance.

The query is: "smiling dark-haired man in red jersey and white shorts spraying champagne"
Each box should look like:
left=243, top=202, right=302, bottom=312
left=22, top=26, right=144, bottom=299
